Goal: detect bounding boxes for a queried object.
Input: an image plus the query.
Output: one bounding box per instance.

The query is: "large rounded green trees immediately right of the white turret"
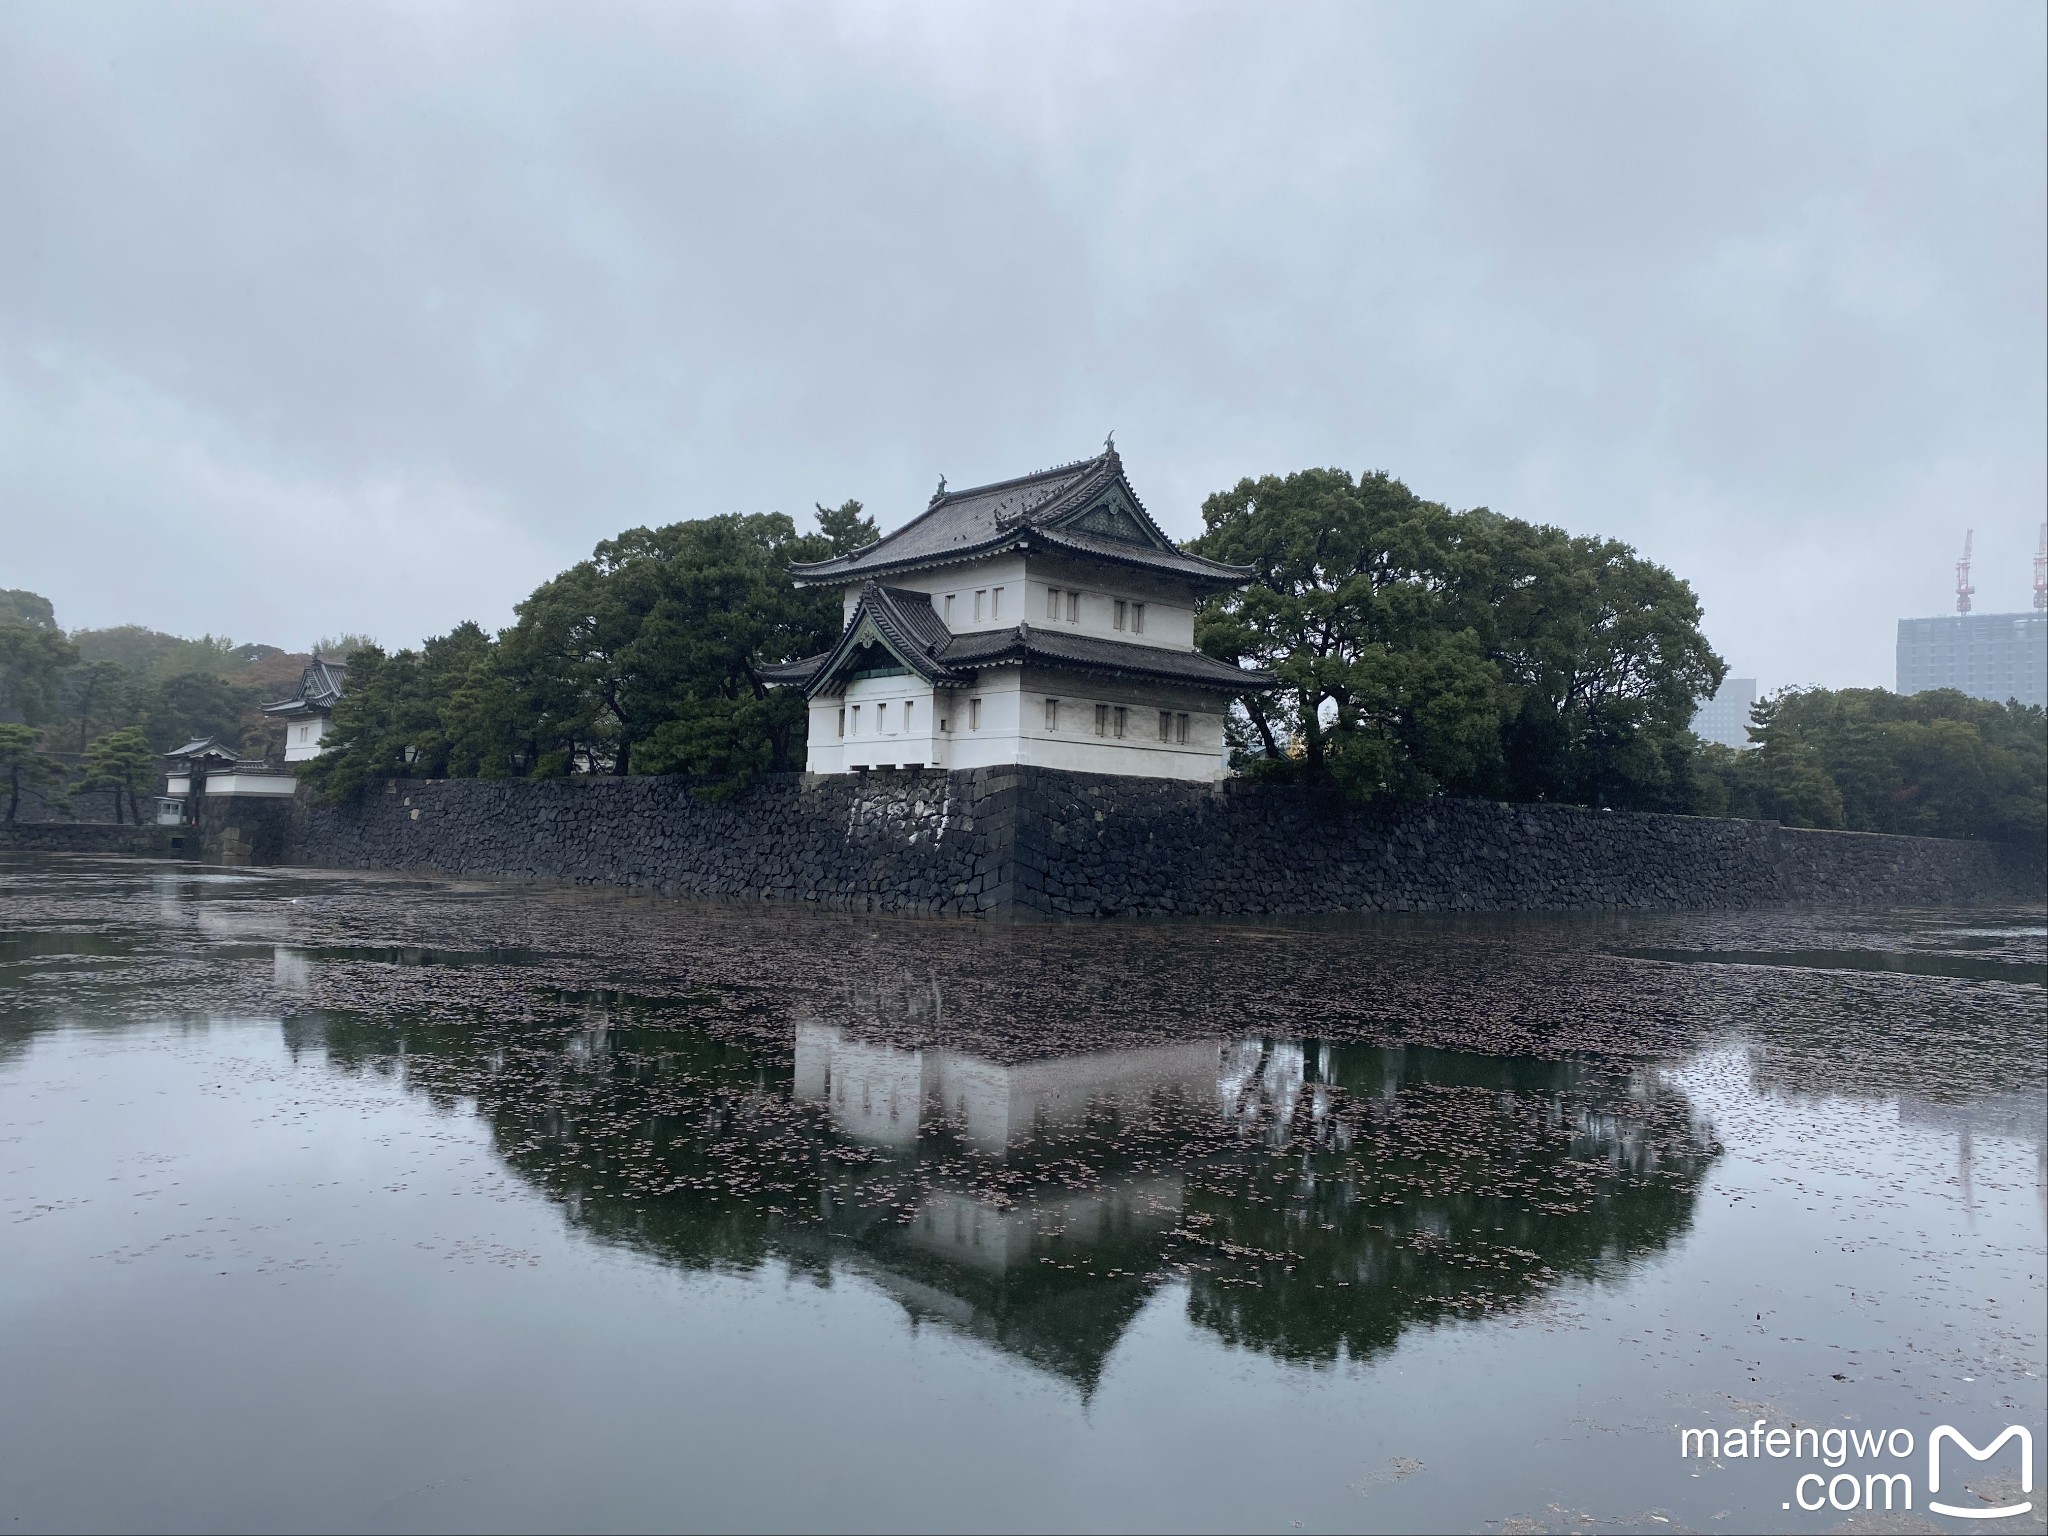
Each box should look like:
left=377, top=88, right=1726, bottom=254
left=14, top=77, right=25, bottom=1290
left=1192, top=469, right=1726, bottom=811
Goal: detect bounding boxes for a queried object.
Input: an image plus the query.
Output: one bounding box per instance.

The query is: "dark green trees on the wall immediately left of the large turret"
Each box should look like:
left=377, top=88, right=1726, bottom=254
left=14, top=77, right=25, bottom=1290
left=307, top=502, right=877, bottom=801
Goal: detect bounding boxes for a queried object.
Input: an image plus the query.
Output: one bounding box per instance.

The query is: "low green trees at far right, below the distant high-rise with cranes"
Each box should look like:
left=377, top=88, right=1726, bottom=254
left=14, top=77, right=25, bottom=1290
left=1698, top=688, right=2048, bottom=846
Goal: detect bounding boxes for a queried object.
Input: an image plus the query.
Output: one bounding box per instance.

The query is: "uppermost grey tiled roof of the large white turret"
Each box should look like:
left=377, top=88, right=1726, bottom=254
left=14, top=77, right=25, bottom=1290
left=788, top=449, right=1251, bottom=586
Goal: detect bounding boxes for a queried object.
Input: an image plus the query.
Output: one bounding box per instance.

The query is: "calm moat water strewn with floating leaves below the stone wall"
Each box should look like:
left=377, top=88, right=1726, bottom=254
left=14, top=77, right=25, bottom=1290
left=0, top=858, right=2048, bottom=1532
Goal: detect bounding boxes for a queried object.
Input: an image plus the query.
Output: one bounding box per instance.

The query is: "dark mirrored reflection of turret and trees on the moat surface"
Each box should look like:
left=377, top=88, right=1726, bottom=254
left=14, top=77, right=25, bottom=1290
left=292, top=974, right=1716, bottom=1391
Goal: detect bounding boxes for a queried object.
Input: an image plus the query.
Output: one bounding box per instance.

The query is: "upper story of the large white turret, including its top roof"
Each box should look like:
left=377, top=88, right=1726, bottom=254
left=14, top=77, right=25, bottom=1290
left=791, top=449, right=1251, bottom=651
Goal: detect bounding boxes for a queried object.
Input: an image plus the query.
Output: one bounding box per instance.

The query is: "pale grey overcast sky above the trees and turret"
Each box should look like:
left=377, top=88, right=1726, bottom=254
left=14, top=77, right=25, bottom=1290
left=0, top=0, right=2048, bottom=686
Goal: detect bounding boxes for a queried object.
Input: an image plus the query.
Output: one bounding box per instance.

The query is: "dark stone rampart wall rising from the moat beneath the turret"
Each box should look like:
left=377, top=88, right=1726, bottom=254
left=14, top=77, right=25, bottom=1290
left=276, top=768, right=2025, bottom=915
